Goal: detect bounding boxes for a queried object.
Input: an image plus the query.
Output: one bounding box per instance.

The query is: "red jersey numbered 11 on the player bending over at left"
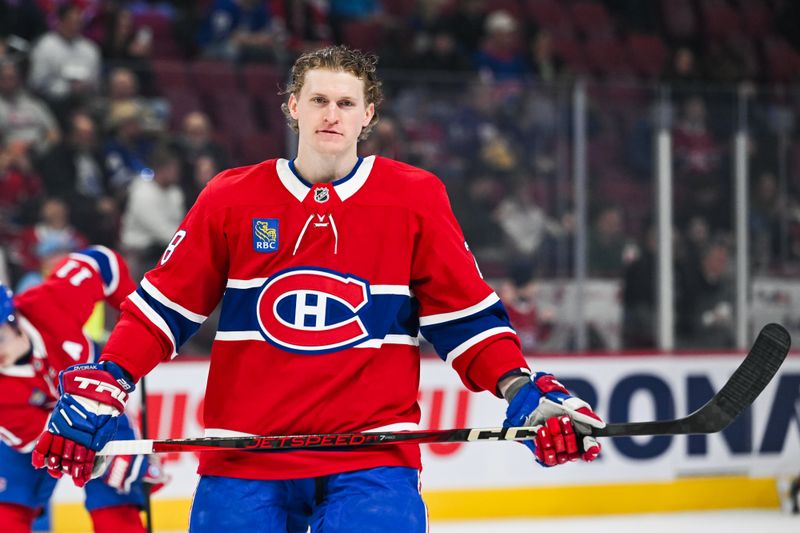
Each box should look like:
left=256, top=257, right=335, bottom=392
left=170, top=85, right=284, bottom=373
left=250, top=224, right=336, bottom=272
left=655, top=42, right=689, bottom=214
left=0, top=246, right=136, bottom=452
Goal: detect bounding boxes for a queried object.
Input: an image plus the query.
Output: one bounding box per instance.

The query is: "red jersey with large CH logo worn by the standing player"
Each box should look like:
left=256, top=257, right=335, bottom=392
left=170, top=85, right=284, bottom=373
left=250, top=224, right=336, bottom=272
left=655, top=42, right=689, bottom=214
left=102, top=156, right=526, bottom=479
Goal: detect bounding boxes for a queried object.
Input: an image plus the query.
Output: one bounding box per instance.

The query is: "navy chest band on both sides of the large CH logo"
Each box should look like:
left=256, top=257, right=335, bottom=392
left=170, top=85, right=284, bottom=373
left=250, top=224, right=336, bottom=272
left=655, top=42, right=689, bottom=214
left=218, top=287, right=419, bottom=339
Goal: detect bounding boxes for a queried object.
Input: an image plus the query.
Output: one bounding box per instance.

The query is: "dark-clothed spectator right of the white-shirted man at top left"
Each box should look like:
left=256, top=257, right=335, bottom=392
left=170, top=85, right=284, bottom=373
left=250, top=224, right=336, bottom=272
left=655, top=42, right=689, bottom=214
left=101, top=6, right=153, bottom=94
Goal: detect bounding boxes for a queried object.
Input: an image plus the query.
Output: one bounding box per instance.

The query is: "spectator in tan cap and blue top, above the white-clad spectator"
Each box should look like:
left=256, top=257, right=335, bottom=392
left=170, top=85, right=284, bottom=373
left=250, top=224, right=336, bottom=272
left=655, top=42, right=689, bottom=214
left=104, top=98, right=152, bottom=192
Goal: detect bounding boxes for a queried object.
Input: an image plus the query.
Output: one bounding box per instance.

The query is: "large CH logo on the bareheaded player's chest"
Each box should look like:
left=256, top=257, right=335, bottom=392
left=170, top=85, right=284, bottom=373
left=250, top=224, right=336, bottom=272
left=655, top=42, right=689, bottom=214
left=256, top=267, right=371, bottom=354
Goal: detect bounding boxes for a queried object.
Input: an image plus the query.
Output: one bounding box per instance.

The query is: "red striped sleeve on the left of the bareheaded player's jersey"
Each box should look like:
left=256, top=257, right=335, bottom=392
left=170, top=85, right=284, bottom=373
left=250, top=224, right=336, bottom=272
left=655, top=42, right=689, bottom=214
left=101, top=177, right=228, bottom=380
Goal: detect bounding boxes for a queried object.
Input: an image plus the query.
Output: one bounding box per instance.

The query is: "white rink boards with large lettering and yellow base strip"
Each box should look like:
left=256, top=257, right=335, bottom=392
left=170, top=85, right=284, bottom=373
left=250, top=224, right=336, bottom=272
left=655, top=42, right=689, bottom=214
left=54, top=353, right=800, bottom=531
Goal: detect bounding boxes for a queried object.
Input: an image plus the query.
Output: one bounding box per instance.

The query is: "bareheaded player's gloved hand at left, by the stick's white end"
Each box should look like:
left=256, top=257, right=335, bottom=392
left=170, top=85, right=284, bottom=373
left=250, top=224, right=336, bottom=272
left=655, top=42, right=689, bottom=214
left=31, top=361, right=135, bottom=487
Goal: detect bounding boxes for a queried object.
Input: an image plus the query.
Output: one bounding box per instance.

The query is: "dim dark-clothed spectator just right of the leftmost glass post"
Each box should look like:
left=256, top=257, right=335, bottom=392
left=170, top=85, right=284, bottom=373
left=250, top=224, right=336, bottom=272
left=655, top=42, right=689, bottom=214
left=588, top=206, right=628, bottom=277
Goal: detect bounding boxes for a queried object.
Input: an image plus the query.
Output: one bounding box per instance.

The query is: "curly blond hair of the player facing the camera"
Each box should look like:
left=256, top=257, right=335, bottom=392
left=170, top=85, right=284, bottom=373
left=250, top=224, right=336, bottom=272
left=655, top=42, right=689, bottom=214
left=280, top=45, right=383, bottom=141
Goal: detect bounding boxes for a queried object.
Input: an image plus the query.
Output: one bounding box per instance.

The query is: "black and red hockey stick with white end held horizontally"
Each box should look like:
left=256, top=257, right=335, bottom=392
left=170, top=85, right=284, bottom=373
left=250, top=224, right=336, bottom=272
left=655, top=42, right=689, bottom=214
left=98, top=324, right=790, bottom=455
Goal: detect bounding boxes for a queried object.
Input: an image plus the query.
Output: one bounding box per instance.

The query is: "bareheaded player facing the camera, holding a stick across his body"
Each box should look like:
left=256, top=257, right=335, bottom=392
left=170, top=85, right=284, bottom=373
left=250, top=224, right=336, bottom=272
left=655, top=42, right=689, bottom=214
left=34, top=47, right=604, bottom=533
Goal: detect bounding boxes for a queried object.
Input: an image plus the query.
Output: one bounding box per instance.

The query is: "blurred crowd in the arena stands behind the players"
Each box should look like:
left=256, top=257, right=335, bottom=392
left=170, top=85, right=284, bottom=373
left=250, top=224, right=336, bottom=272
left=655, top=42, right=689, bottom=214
left=0, top=0, right=800, bottom=350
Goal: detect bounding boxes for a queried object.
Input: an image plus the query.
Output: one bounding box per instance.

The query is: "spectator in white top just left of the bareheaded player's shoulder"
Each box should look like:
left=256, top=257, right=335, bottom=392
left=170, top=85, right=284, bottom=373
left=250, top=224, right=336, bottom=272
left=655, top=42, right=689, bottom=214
left=120, top=145, right=186, bottom=279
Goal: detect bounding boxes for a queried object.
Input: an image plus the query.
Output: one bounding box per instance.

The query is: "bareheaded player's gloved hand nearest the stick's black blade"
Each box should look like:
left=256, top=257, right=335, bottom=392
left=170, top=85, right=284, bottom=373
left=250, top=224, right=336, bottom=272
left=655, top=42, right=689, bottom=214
left=503, top=372, right=606, bottom=466
